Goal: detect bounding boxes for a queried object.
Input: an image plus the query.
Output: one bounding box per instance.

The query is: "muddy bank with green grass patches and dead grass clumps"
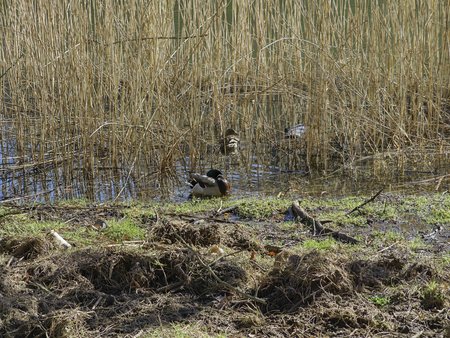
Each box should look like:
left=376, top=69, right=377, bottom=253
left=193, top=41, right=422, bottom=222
left=0, top=193, right=450, bottom=337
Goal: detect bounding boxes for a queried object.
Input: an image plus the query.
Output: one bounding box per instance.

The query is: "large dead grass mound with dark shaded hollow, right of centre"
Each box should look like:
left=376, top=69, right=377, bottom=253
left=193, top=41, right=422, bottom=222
left=258, top=251, right=353, bottom=312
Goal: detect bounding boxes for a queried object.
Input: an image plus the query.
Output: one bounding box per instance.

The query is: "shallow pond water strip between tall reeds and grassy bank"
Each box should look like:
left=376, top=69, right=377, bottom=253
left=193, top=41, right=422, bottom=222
left=0, top=133, right=450, bottom=203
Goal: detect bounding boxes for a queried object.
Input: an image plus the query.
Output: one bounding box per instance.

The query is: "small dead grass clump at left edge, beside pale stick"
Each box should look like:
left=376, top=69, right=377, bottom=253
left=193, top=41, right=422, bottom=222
left=0, top=237, right=51, bottom=259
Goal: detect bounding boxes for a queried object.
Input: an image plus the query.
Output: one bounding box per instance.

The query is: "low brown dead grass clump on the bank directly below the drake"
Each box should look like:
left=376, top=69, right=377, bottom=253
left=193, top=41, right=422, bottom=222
left=150, top=221, right=220, bottom=247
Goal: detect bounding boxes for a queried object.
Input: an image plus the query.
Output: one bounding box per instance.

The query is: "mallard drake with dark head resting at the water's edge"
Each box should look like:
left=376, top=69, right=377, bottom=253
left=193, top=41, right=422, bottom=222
left=190, top=169, right=230, bottom=197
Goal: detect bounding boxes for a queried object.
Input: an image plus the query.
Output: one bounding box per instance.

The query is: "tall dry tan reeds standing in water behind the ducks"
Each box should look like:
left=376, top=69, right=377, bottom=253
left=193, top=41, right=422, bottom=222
left=0, top=0, right=450, bottom=201
